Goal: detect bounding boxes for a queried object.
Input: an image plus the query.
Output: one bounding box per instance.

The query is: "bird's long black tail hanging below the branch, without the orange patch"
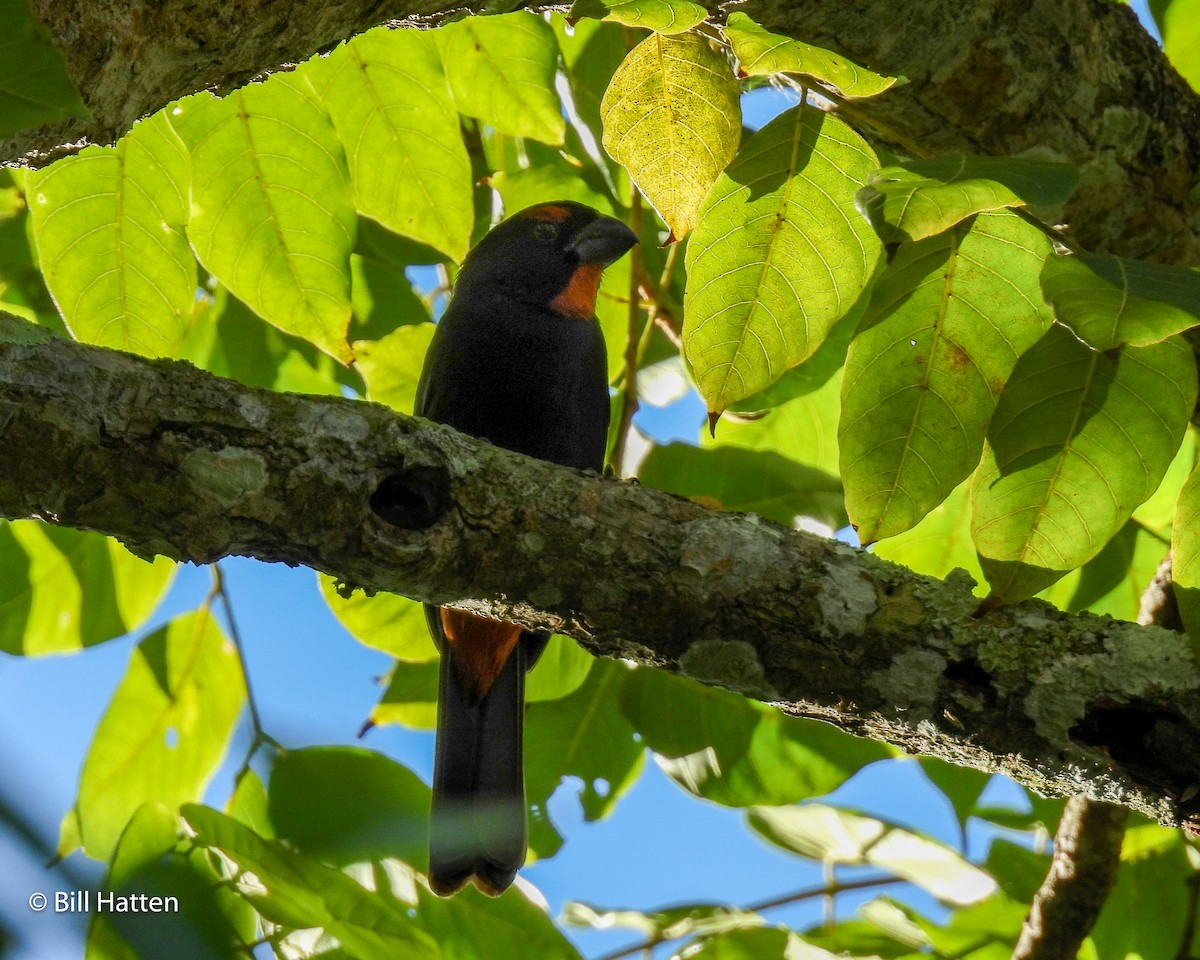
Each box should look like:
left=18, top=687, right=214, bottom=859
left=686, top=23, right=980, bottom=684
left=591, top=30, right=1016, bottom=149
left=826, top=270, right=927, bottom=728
left=430, top=641, right=527, bottom=896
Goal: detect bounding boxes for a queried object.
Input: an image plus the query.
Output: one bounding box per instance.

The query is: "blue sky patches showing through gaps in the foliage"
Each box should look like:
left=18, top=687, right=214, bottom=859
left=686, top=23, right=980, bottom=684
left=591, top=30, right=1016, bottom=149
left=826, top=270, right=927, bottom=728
left=0, top=2, right=1148, bottom=960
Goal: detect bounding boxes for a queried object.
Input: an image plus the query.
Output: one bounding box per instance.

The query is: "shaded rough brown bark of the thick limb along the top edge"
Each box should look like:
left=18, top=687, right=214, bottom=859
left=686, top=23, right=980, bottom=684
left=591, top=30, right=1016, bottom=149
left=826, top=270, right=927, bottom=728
left=9, top=0, right=1200, bottom=272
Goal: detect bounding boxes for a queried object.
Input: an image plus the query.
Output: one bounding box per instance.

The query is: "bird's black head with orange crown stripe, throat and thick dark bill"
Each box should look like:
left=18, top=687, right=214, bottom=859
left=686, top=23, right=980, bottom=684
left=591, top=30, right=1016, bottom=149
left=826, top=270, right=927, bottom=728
left=457, top=200, right=637, bottom=318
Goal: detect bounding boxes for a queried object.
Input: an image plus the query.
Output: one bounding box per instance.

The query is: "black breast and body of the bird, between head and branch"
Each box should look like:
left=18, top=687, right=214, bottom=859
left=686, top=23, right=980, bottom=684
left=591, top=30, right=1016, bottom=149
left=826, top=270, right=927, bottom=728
left=416, top=298, right=608, bottom=470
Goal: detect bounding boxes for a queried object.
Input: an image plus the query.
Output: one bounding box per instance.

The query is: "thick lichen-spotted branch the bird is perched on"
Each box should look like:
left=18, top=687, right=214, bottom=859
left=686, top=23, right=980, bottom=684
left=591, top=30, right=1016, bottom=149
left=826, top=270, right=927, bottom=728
left=7, top=331, right=1200, bottom=822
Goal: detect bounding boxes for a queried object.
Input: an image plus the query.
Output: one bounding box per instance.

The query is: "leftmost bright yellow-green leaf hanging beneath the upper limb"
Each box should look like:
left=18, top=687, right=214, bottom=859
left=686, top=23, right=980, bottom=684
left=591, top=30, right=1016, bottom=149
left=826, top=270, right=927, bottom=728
left=29, top=113, right=196, bottom=356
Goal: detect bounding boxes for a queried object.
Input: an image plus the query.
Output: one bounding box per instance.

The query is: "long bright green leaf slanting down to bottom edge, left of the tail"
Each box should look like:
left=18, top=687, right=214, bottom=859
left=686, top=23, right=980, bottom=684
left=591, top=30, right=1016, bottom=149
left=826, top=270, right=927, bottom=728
left=181, top=804, right=442, bottom=960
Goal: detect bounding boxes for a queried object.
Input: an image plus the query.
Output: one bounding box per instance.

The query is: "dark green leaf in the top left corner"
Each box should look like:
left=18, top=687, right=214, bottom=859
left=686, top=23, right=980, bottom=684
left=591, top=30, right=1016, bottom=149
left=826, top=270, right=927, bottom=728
left=0, top=0, right=91, bottom=137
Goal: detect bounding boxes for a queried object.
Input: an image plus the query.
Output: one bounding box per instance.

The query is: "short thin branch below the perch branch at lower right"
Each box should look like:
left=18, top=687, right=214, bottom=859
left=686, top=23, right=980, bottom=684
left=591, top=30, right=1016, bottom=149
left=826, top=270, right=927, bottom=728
left=1013, top=796, right=1129, bottom=960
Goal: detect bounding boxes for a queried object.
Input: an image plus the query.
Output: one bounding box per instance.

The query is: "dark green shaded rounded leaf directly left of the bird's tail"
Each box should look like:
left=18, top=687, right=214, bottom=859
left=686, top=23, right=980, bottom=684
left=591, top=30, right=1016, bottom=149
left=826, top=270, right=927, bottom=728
left=269, top=746, right=430, bottom=866
